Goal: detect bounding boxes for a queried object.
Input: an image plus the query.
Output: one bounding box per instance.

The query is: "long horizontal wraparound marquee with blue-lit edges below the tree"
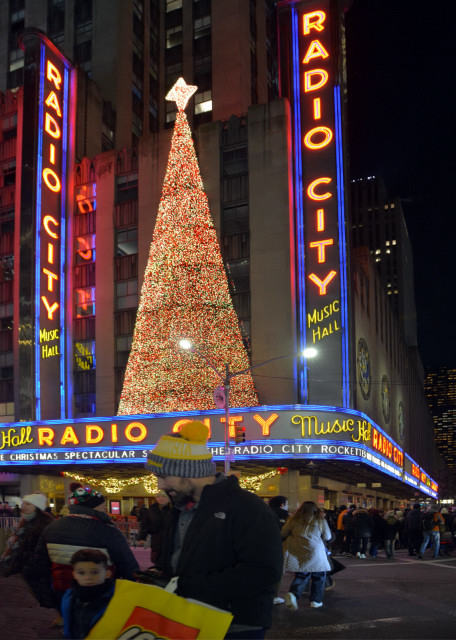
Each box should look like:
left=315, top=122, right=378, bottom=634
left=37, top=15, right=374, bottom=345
left=0, top=405, right=438, bottom=496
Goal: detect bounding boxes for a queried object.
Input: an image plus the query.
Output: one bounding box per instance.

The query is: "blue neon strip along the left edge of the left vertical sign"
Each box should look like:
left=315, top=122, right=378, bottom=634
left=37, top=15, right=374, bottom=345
left=35, top=45, right=46, bottom=420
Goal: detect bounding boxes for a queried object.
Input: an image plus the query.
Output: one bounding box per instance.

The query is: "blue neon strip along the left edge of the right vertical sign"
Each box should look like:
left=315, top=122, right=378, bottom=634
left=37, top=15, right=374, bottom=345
left=291, top=7, right=308, bottom=403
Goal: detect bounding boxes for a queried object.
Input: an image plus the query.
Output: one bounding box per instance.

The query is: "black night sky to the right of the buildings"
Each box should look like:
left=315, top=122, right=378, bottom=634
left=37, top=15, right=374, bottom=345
left=346, top=0, right=456, bottom=367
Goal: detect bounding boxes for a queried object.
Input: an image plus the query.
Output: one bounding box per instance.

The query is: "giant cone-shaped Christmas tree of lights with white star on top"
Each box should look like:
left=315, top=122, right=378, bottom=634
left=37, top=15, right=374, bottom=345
left=118, top=78, right=258, bottom=415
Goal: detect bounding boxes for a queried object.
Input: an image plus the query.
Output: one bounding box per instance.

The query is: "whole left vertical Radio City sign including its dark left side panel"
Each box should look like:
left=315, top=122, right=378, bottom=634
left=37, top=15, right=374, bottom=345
left=18, top=30, right=76, bottom=420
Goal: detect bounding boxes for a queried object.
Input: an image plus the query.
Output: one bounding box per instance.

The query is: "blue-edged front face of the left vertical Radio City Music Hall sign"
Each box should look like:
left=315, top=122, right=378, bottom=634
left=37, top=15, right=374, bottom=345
left=31, top=34, right=75, bottom=420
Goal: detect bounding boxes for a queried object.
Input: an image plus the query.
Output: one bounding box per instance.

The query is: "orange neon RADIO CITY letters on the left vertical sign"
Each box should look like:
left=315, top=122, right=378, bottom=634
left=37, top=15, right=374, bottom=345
left=41, top=59, right=63, bottom=322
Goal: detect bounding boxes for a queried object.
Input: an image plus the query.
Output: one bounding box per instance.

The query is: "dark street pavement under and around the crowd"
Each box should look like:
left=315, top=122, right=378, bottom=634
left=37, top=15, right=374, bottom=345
left=0, top=548, right=456, bottom=640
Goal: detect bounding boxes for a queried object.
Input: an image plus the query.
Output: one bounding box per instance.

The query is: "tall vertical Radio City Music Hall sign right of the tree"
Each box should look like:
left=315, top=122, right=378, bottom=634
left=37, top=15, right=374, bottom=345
left=278, top=0, right=350, bottom=406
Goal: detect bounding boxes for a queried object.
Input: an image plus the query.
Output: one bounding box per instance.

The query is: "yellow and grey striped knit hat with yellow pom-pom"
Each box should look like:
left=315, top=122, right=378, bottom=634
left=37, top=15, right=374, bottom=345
left=146, top=421, right=215, bottom=478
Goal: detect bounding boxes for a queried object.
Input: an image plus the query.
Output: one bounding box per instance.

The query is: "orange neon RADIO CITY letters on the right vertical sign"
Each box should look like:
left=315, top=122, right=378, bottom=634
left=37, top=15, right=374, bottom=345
left=300, top=11, right=337, bottom=296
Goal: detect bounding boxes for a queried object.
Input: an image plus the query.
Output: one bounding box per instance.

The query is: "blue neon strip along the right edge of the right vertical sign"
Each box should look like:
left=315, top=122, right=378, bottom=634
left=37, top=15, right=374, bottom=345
left=334, top=86, right=350, bottom=405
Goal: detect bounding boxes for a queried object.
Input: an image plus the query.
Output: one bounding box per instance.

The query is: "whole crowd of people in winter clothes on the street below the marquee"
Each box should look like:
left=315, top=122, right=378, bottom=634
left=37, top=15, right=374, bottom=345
left=0, top=428, right=456, bottom=640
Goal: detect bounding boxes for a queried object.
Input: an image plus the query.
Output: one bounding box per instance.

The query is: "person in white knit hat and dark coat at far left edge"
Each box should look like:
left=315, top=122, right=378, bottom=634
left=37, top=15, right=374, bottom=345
left=0, top=493, right=55, bottom=597
